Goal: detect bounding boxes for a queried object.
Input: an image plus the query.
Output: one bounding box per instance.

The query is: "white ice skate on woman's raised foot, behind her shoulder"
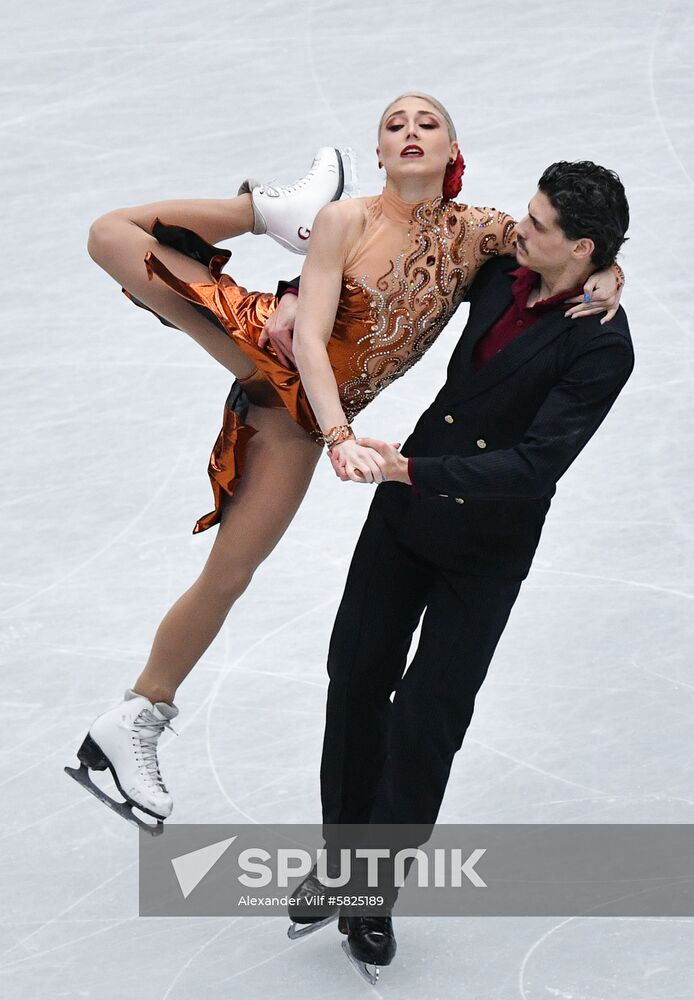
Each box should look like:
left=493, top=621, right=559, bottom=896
left=239, top=146, right=357, bottom=254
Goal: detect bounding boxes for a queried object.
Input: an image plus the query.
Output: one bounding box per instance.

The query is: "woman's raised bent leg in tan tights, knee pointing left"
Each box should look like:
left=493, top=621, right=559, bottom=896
left=87, top=194, right=255, bottom=378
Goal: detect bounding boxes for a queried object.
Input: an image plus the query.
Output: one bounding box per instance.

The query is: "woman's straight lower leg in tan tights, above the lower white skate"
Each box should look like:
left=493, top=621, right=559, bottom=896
left=134, top=406, right=321, bottom=704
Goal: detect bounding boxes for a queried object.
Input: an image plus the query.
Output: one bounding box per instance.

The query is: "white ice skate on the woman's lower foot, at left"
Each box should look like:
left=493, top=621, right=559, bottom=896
left=65, top=690, right=178, bottom=835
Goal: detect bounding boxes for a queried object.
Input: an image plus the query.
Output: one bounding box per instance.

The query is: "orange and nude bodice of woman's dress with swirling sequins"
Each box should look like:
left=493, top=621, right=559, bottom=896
left=328, top=188, right=515, bottom=420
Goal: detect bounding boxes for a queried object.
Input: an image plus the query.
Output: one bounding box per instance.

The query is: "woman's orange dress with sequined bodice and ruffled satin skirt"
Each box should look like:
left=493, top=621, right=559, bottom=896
left=123, top=188, right=515, bottom=534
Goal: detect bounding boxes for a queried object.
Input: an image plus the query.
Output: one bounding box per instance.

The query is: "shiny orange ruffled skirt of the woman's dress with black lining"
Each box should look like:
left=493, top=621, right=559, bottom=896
left=121, top=219, right=323, bottom=535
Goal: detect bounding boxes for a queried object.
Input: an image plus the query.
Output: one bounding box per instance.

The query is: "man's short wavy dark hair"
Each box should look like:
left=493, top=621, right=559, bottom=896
left=538, top=160, right=629, bottom=270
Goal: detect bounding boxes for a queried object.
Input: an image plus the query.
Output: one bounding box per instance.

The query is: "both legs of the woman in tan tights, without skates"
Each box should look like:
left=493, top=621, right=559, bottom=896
left=88, top=195, right=321, bottom=704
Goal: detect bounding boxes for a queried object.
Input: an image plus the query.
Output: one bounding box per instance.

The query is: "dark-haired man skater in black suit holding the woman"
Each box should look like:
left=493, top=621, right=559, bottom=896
left=256, top=161, right=634, bottom=981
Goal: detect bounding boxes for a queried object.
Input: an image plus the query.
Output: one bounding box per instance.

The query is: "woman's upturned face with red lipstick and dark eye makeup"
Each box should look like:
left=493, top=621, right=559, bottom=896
left=376, top=97, right=458, bottom=189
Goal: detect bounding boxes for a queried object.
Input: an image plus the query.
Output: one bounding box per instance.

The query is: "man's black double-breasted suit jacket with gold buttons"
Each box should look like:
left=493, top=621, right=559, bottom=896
left=372, top=257, right=634, bottom=579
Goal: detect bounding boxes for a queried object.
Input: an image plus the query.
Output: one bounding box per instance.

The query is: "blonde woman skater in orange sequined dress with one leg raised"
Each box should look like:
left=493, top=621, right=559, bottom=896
left=66, top=94, right=620, bottom=832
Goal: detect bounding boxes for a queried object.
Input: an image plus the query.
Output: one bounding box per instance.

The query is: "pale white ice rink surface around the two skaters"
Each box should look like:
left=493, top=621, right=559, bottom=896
left=0, top=0, right=694, bottom=1000
